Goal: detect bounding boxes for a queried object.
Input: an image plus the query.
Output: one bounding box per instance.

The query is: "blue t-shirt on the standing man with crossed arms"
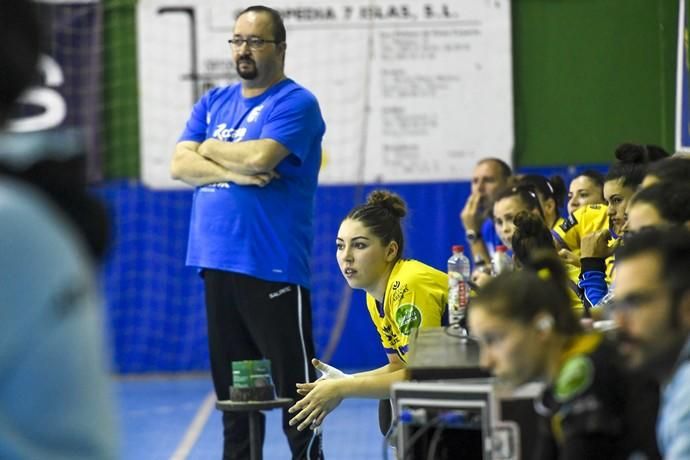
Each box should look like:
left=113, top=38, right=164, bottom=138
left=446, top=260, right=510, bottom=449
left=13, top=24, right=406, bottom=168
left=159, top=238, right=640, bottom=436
left=179, top=79, right=326, bottom=287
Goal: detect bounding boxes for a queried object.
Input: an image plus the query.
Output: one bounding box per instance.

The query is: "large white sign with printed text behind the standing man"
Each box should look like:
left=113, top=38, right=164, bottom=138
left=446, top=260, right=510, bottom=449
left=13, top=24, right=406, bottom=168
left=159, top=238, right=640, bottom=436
left=137, top=0, right=514, bottom=188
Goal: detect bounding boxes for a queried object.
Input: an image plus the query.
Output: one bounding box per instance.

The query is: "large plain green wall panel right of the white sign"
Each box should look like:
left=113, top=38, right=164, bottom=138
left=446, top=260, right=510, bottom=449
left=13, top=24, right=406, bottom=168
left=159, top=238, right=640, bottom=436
left=512, top=0, right=678, bottom=166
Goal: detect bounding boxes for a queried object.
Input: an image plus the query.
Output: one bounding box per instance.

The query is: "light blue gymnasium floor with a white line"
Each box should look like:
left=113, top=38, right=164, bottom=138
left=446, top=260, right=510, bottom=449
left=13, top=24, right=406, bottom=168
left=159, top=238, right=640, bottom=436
left=115, top=375, right=393, bottom=460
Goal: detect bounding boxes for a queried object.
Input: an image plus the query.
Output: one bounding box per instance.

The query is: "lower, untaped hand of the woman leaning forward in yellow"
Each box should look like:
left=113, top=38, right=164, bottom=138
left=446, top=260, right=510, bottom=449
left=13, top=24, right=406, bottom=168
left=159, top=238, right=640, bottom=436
left=288, top=377, right=345, bottom=431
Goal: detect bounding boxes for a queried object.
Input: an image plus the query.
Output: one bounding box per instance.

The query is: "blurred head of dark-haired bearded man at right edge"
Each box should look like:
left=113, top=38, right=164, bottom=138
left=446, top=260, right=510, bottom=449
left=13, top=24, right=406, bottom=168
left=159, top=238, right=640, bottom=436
left=612, top=226, right=690, bottom=378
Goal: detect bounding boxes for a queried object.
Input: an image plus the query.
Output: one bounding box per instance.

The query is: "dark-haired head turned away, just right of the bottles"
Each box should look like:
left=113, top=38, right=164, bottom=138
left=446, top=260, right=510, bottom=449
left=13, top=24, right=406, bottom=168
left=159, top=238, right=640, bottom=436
left=511, top=211, right=556, bottom=268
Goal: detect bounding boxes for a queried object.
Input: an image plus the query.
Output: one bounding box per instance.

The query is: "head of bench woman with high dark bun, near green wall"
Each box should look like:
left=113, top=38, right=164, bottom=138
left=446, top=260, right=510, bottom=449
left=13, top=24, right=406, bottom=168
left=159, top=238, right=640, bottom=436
left=604, top=144, right=668, bottom=235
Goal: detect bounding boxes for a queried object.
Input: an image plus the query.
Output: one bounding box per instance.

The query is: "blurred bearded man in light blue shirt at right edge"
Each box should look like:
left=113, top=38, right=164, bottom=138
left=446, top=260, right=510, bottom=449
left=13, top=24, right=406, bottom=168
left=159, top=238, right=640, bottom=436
left=611, top=226, right=690, bottom=460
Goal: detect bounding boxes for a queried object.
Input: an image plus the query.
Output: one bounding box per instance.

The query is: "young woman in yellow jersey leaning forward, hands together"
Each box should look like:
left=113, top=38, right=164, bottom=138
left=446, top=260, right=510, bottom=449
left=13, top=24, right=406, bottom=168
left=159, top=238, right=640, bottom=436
left=290, top=190, right=448, bottom=430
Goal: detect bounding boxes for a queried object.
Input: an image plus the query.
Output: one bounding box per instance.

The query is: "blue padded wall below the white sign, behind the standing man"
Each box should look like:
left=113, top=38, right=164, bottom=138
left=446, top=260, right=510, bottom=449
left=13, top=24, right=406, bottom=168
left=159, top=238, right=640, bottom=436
left=96, top=166, right=602, bottom=373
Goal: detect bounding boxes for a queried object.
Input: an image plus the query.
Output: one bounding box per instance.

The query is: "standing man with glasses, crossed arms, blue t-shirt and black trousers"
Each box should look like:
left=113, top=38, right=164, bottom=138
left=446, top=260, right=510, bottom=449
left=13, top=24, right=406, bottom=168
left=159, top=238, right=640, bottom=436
left=171, top=5, right=326, bottom=459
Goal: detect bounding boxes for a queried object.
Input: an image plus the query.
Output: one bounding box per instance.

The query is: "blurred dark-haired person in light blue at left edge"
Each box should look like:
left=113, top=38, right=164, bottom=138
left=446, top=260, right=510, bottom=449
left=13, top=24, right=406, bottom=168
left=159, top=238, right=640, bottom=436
left=0, top=0, right=118, bottom=460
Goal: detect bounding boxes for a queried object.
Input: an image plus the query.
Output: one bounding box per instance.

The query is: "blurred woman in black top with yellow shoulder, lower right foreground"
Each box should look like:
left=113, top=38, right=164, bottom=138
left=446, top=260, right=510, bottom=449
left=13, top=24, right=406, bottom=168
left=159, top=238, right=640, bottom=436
left=469, top=251, right=658, bottom=460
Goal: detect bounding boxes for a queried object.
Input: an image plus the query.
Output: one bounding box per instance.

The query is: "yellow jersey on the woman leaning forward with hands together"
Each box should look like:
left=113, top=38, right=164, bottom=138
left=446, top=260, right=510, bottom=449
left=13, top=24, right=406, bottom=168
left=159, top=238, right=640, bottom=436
left=367, top=260, right=448, bottom=362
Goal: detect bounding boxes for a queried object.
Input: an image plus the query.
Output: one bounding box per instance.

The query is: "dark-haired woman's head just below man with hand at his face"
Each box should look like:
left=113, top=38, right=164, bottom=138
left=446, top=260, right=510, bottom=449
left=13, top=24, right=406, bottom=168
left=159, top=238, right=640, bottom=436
left=491, top=184, right=544, bottom=249
